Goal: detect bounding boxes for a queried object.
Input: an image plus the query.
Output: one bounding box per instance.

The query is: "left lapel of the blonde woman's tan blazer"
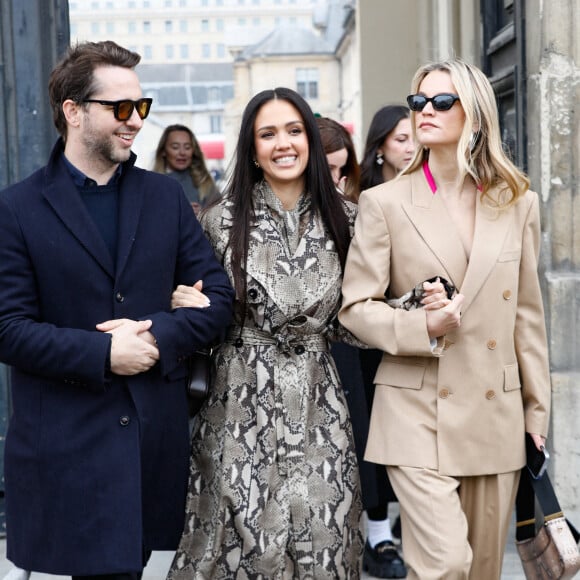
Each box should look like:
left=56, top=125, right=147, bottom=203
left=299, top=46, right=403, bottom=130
left=402, top=171, right=467, bottom=288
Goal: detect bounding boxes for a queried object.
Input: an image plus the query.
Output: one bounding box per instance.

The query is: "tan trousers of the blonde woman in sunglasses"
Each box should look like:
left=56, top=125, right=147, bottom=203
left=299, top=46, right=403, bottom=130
left=387, top=466, right=520, bottom=580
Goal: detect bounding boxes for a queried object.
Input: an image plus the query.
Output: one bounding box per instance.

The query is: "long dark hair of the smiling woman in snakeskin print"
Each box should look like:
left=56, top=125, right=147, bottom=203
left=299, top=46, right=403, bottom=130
left=225, top=87, right=350, bottom=311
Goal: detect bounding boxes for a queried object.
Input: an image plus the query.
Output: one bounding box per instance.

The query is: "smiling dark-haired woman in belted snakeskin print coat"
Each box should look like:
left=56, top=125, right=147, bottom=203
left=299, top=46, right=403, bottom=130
left=168, top=88, right=362, bottom=580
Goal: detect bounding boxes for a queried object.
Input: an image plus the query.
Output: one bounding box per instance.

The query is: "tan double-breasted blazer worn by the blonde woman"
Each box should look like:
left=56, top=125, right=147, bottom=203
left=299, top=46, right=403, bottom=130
left=339, top=171, right=550, bottom=476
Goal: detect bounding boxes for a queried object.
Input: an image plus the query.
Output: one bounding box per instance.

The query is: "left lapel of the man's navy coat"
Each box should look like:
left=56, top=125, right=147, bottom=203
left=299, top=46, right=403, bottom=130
left=44, top=170, right=114, bottom=277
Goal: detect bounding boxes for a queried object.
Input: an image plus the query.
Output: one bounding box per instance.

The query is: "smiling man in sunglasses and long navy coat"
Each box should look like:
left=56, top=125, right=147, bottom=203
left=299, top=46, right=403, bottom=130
left=0, top=41, right=233, bottom=580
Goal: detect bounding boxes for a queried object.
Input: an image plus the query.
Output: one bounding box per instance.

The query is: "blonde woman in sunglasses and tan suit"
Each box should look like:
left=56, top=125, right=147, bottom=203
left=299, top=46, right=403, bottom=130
left=339, top=60, right=550, bottom=580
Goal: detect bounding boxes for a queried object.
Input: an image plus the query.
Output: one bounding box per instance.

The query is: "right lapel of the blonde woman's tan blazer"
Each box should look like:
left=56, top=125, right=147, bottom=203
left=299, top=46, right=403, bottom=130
left=458, top=191, right=513, bottom=312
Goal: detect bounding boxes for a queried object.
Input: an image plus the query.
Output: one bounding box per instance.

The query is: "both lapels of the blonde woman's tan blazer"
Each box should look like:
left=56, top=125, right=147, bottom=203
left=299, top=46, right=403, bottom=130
left=403, top=171, right=513, bottom=312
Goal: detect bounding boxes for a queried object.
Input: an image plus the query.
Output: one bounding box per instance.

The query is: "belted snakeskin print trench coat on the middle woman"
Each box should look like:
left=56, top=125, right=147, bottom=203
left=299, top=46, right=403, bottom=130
left=168, top=182, right=363, bottom=580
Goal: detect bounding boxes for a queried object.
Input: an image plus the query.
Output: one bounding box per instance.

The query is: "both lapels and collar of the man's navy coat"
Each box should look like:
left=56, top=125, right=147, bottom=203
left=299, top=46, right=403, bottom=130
left=43, top=139, right=142, bottom=278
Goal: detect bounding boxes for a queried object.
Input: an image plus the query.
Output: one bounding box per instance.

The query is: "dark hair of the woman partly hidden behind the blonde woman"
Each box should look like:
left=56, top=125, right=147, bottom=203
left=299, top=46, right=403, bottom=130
left=360, top=105, right=410, bottom=191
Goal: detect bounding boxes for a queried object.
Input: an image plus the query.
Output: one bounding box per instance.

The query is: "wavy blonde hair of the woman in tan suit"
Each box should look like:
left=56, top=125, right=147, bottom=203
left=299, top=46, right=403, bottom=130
left=401, top=59, right=530, bottom=208
